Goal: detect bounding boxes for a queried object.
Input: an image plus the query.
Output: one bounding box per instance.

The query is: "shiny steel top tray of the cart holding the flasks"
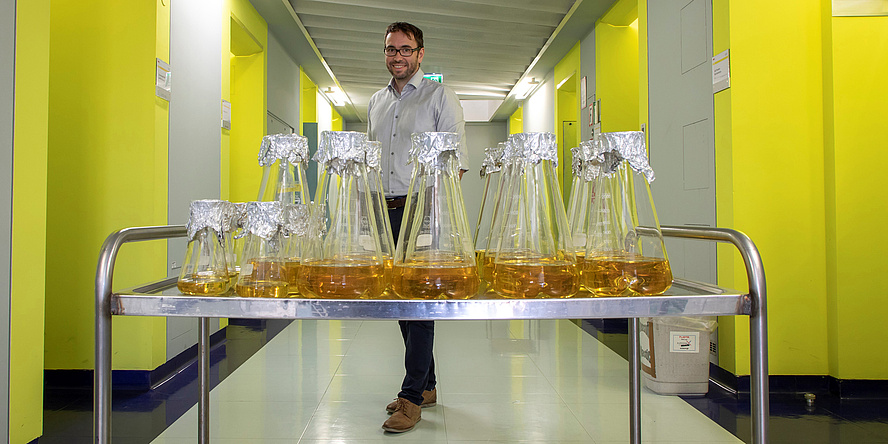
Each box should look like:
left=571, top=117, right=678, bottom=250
left=111, top=278, right=751, bottom=320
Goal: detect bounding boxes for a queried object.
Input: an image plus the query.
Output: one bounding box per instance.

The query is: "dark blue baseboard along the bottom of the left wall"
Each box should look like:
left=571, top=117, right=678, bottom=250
left=43, top=327, right=225, bottom=391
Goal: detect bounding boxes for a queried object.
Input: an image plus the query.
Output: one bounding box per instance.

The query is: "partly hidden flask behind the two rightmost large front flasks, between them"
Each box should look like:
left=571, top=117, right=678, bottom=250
left=567, top=140, right=598, bottom=292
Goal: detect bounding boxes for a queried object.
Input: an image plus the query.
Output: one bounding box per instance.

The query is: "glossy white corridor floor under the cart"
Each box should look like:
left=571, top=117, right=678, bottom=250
left=154, top=321, right=740, bottom=444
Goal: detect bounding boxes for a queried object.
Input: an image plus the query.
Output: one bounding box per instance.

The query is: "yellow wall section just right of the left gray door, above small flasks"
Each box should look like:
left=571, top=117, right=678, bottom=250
left=222, top=0, right=268, bottom=202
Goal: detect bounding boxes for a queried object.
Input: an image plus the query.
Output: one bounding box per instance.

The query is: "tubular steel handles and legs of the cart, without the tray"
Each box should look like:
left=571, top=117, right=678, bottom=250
left=93, top=225, right=769, bottom=444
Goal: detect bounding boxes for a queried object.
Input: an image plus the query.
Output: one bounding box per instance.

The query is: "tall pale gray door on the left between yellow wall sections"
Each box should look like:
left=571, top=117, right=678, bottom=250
left=167, top=1, right=224, bottom=359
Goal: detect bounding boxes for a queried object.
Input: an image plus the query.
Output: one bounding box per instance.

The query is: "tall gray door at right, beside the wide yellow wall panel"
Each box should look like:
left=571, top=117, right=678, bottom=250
left=648, top=0, right=716, bottom=283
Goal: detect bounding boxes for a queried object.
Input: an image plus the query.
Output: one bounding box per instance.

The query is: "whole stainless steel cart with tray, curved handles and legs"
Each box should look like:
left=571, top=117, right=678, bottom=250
left=93, top=225, right=769, bottom=444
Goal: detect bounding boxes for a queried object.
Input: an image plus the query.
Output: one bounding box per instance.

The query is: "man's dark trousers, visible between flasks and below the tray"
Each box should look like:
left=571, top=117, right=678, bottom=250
left=389, top=207, right=436, bottom=405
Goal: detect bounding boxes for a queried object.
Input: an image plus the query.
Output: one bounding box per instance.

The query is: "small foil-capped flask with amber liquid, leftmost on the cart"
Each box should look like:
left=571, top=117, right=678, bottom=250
left=176, top=200, right=230, bottom=296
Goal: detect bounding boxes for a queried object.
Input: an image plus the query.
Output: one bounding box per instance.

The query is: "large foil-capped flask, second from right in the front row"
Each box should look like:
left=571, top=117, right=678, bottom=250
left=493, top=133, right=580, bottom=298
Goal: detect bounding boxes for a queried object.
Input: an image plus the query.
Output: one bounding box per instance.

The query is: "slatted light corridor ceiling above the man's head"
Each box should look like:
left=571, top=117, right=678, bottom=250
left=288, top=0, right=575, bottom=121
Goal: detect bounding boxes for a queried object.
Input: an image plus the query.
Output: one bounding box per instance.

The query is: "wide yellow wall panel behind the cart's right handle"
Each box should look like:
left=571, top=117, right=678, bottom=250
left=714, top=0, right=829, bottom=375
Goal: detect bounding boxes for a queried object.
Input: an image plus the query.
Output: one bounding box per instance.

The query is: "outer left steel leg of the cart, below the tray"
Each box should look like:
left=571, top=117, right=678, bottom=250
left=93, top=295, right=111, bottom=444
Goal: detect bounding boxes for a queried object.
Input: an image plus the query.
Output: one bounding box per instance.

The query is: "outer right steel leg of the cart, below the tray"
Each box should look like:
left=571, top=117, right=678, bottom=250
left=749, top=305, right=770, bottom=444
